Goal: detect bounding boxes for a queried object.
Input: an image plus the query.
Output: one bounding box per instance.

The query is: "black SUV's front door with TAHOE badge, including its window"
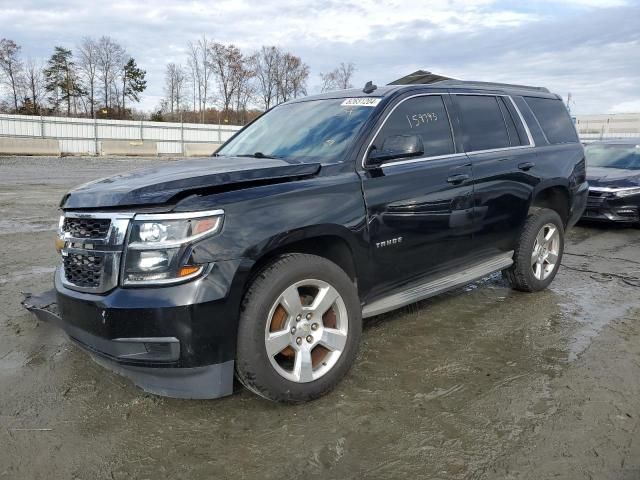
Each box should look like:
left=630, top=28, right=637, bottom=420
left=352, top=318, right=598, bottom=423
left=362, top=94, right=473, bottom=296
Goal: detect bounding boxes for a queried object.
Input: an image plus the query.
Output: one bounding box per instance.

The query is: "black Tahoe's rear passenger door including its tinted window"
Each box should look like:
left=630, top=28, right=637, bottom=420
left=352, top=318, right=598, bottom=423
left=452, top=93, right=537, bottom=257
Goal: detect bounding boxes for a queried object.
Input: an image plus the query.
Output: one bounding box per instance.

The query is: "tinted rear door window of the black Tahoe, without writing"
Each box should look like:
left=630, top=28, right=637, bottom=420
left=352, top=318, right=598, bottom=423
left=457, top=95, right=511, bottom=152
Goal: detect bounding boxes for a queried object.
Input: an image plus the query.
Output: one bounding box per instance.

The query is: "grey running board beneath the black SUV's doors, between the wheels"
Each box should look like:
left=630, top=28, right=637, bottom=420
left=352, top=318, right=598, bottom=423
left=362, top=250, right=513, bottom=318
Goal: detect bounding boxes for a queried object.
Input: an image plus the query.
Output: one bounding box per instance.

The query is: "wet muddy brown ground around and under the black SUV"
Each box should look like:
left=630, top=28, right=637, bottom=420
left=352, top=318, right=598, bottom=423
left=0, top=158, right=640, bottom=480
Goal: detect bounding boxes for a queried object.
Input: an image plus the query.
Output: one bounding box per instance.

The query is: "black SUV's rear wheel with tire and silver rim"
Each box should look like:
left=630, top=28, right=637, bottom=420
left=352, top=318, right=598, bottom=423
left=502, top=208, right=564, bottom=292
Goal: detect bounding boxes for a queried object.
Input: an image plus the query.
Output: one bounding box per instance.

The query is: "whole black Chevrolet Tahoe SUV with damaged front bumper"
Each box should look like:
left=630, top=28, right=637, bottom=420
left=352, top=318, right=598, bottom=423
left=25, top=80, right=588, bottom=402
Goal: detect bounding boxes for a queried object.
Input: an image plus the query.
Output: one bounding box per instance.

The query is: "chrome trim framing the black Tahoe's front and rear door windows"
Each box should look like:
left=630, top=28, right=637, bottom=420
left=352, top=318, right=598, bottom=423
left=361, top=92, right=537, bottom=169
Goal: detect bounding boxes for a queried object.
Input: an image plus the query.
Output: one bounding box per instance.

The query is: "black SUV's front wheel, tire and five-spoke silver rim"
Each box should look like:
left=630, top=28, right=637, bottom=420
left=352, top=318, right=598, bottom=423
left=236, top=253, right=362, bottom=403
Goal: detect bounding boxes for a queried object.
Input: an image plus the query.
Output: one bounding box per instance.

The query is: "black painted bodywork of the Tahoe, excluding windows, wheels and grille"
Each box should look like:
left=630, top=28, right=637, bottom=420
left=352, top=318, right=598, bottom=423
left=26, top=82, right=587, bottom=400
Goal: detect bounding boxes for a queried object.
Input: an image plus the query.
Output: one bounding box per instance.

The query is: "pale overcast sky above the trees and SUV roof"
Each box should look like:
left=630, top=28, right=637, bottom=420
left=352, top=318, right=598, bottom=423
left=0, top=0, right=640, bottom=113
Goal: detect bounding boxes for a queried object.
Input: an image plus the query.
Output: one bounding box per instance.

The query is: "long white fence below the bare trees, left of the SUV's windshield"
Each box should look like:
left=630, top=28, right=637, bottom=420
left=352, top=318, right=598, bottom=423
left=0, top=115, right=241, bottom=155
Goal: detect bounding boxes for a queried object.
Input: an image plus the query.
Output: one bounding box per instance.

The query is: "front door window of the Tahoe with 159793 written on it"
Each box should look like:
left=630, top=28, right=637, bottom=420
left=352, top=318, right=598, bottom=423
left=373, top=95, right=455, bottom=157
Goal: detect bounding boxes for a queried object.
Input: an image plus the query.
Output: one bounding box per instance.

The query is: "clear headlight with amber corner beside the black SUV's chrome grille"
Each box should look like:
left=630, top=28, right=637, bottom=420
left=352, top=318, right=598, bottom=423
left=123, top=210, right=224, bottom=285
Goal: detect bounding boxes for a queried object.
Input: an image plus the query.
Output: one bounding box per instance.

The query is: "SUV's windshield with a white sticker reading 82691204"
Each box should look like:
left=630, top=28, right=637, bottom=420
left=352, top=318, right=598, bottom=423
left=218, top=98, right=378, bottom=163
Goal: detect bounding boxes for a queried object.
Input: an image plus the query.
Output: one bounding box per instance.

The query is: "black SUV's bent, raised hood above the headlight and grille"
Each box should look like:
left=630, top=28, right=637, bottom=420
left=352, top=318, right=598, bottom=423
left=60, top=157, right=320, bottom=209
